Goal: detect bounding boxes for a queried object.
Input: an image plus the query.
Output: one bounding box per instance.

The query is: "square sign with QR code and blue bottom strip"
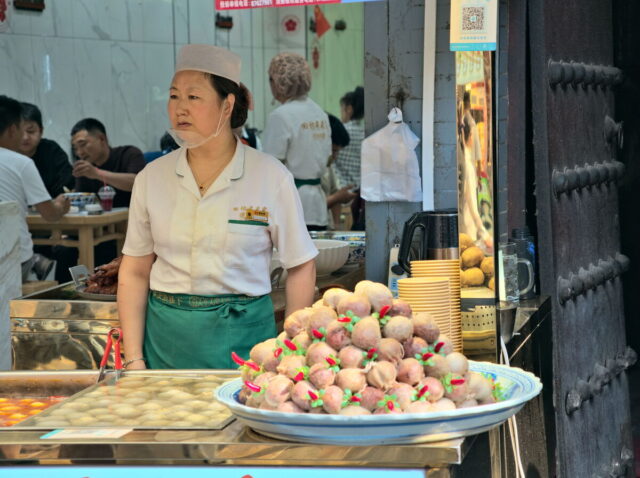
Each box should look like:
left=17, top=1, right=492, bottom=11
left=450, top=0, right=498, bottom=51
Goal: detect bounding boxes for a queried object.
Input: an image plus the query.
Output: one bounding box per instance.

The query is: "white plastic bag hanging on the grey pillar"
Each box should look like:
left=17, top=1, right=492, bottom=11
left=360, top=108, right=422, bottom=202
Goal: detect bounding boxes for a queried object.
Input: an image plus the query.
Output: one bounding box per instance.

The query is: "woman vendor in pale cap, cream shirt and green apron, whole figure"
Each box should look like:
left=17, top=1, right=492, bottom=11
left=118, top=45, right=318, bottom=369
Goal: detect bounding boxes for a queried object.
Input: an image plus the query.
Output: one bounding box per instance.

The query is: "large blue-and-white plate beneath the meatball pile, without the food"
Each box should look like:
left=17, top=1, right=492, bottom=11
left=216, top=361, right=542, bottom=445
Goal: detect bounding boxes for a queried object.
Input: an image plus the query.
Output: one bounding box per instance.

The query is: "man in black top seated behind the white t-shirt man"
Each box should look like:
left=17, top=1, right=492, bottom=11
left=19, top=103, right=75, bottom=197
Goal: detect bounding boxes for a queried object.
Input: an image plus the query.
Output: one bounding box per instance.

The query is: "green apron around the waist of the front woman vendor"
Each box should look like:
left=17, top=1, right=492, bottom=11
left=143, top=291, right=276, bottom=369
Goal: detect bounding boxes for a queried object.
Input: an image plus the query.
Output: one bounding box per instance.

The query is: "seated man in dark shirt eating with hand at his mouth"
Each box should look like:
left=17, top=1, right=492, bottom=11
left=71, top=118, right=146, bottom=207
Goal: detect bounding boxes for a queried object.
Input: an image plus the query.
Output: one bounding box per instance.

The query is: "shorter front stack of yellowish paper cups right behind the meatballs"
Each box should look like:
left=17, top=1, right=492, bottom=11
left=398, top=277, right=459, bottom=351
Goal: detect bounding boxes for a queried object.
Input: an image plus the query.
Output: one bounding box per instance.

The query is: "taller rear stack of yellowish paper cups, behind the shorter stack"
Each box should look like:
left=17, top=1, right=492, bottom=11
left=411, top=259, right=462, bottom=352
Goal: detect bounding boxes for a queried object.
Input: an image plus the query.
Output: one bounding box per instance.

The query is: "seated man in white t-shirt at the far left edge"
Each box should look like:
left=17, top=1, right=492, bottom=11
left=0, top=95, right=70, bottom=282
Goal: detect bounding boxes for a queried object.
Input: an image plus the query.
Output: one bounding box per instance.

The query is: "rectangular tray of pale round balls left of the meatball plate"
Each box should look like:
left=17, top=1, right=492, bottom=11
left=11, top=370, right=238, bottom=430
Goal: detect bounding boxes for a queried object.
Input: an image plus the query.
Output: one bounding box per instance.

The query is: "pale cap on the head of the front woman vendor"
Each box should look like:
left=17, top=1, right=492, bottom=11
left=176, top=44, right=242, bottom=84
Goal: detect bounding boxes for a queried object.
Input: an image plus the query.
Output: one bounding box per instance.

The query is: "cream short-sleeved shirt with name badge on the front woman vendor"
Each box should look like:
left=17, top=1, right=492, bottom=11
left=122, top=141, right=318, bottom=296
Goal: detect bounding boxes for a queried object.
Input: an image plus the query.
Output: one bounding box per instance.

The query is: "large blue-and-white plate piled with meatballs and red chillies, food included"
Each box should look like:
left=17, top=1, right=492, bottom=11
left=215, top=281, right=542, bottom=445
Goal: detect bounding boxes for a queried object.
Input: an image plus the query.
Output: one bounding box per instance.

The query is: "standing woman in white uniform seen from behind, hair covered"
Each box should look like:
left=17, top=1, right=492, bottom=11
left=262, top=53, right=331, bottom=231
